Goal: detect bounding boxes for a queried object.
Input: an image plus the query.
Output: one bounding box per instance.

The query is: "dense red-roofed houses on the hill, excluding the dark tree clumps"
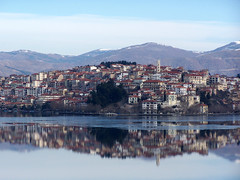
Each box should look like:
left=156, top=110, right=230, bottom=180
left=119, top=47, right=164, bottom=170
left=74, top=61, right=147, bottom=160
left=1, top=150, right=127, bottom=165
left=0, top=60, right=240, bottom=114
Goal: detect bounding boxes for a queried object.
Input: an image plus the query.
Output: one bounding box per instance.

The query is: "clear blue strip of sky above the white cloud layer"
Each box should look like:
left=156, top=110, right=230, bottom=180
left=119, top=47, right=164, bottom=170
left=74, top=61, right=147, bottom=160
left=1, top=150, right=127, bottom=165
left=0, top=0, right=240, bottom=23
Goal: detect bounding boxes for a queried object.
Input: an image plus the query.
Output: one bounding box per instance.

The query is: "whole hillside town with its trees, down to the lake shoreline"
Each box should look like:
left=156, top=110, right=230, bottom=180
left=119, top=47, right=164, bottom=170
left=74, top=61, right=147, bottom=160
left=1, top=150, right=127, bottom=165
left=0, top=60, right=240, bottom=115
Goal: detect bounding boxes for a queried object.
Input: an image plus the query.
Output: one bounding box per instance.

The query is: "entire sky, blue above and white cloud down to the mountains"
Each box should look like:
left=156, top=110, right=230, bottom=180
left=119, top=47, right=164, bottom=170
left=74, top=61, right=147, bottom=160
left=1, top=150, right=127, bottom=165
left=0, top=0, right=240, bottom=55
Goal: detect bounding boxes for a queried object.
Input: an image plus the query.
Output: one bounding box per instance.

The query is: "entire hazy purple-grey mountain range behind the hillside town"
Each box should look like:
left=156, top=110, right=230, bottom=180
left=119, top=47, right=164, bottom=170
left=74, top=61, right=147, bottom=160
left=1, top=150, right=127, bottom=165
left=0, top=41, right=240, bottom=76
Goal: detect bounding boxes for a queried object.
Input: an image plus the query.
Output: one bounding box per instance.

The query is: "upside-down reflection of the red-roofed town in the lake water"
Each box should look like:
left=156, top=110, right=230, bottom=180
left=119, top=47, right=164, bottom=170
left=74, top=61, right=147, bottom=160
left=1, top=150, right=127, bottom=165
left=0, top=123, right=240, bottom=165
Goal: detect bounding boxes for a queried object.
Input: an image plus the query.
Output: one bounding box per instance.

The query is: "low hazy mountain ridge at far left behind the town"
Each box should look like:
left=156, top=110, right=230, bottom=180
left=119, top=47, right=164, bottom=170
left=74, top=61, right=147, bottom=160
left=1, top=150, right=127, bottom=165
left=0, top=50, right=72, bottom=76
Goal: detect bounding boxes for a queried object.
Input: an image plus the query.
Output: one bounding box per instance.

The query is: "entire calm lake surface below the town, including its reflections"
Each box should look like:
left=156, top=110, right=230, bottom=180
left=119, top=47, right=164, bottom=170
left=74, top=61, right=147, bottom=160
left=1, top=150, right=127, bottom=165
left=0, top=115, right=240, bottom=180
